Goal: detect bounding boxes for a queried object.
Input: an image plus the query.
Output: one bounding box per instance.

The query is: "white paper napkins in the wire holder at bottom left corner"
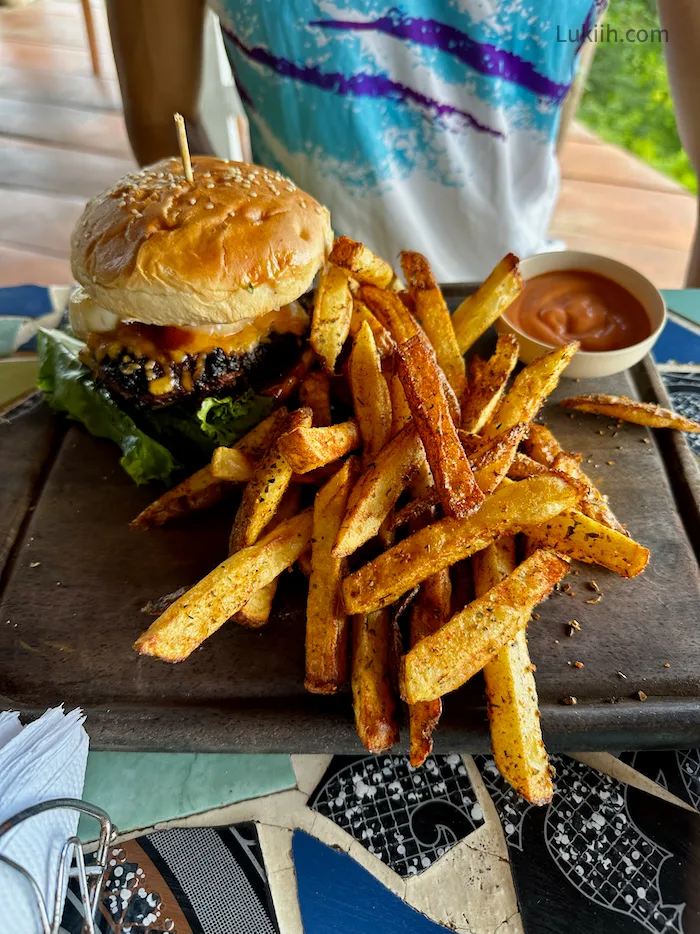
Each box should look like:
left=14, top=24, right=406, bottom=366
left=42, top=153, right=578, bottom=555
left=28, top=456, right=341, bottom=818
left=0, top=707, right=88, bottom=934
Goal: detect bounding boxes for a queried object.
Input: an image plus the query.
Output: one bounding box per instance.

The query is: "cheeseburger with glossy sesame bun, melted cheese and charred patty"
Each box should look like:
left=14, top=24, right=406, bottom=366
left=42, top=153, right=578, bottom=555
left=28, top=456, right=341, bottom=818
left=70, top=157, right=332, bottom=413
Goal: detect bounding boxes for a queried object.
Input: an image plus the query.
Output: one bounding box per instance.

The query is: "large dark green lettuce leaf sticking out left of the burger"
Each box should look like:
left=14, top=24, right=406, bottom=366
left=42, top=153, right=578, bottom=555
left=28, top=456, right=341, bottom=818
left=37, top=328, right=180, bottom=483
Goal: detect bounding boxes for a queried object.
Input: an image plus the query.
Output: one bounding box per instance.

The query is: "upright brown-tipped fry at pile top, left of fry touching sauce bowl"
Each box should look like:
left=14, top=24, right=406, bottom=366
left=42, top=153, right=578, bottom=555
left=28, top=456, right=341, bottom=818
left=401, top=250, right=467, bottom=399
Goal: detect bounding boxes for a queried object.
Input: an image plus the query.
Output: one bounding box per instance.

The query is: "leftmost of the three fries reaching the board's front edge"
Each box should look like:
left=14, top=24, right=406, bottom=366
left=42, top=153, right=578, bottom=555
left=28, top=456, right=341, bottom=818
left=351, top=610, right=399, bottom=755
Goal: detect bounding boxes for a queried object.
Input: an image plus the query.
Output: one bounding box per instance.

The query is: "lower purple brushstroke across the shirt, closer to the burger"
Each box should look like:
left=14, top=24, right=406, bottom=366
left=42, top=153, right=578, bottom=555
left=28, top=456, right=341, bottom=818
left=222, top=24, right=505, bottom=139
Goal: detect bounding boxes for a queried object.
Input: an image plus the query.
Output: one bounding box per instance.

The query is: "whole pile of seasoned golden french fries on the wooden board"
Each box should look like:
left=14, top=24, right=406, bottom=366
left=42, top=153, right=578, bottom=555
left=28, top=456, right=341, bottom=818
left=132, top=237, right=700, bottom=804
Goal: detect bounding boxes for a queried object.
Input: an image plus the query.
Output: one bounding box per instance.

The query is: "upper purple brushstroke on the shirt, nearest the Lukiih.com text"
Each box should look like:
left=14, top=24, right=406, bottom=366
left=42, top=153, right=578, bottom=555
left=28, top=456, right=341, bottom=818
left=309, top=8, right=569, bottom=103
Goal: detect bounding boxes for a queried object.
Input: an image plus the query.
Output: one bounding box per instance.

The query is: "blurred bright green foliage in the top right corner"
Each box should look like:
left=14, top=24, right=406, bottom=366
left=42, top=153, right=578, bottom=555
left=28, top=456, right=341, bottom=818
left=578, top=0, right=700, bottom=192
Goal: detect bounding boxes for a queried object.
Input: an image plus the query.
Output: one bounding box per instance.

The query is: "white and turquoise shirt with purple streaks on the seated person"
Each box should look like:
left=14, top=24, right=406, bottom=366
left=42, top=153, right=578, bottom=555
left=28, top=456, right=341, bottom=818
left=209, top=0, right=605, bottom=281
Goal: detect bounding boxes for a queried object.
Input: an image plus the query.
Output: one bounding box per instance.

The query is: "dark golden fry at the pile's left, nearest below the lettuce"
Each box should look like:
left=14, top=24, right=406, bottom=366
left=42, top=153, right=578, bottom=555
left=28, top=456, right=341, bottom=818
left=130, top=408, right=287, bottom=530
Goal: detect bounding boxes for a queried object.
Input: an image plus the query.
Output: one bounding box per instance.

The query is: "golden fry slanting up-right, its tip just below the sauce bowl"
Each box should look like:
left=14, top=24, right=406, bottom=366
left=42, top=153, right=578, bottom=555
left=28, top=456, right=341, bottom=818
left=482, top=341, right=579, bottom=438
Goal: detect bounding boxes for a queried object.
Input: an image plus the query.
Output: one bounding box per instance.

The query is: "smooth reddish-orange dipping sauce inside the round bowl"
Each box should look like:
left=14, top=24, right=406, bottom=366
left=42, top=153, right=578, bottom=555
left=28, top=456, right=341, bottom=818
left=504, top=269, right=652, bottom=353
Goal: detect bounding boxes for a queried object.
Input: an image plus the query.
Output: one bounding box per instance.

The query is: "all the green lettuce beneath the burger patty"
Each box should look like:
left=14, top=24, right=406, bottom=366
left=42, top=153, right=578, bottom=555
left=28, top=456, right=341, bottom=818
left=38, top=328, right=273, bottom=483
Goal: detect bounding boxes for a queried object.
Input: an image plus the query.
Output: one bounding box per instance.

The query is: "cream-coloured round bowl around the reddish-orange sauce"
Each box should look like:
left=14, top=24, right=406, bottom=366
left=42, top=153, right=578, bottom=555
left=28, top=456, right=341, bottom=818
left=496, top=250, right=666, bottom=379
